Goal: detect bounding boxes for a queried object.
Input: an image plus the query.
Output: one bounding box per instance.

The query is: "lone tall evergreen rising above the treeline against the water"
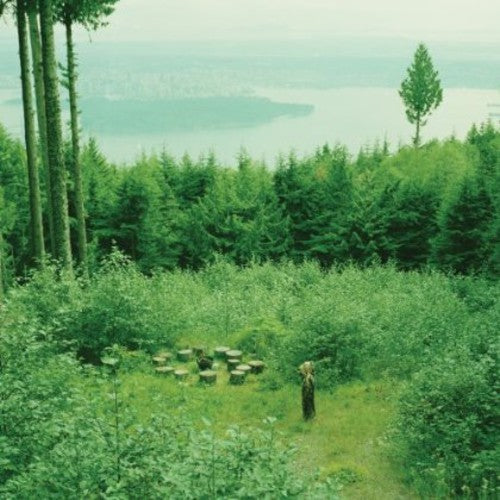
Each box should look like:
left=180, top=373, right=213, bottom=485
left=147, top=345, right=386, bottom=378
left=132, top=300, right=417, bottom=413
left=399, top=43, right=443, bottom=146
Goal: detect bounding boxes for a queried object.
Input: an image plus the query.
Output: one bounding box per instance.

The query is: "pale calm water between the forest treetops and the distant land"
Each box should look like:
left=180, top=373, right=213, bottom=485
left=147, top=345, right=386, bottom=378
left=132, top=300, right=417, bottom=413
left=0, top=87, right=500, bottom=164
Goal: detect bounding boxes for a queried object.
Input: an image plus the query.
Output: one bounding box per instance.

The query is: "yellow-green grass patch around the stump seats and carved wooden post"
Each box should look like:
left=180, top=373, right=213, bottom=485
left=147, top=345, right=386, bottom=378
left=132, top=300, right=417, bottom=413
left=120, top=352, right=417, bottom=499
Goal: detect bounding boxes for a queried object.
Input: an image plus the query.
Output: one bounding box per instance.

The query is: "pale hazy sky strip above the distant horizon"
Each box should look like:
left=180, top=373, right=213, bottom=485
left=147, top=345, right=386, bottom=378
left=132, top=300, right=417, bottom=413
left=0, top=0, right=500, bottom=43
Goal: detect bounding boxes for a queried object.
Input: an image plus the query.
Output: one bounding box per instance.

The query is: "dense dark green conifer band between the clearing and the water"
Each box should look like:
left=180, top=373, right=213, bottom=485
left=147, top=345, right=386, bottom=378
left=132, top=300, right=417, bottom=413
left=0, top=118, right=500, bottom=283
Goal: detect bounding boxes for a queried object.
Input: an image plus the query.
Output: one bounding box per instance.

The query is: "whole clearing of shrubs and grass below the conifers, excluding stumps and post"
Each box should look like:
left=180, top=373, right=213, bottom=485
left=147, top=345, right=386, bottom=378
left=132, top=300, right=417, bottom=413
left=0, top=251, right=500, bottom=498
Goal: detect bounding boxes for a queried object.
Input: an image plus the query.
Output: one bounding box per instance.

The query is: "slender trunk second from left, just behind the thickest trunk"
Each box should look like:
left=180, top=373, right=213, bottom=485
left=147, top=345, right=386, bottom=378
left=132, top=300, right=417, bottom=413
left=28, top=0, right=56, bottom=255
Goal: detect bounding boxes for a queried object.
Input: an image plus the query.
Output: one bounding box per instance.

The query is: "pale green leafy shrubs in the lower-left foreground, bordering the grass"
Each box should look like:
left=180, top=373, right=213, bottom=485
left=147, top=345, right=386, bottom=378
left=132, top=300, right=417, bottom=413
left=0, top=325, right=337, bottom=499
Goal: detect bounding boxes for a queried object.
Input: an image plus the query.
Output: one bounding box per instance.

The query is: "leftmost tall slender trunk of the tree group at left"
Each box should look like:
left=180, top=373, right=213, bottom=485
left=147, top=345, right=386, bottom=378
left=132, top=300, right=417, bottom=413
left=16, top=0, right=45, bottom=265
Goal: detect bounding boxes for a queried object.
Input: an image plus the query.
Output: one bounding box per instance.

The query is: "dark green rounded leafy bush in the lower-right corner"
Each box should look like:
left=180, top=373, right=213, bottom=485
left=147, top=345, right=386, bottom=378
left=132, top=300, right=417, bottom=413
left=397, top=345, right=500, bottom=498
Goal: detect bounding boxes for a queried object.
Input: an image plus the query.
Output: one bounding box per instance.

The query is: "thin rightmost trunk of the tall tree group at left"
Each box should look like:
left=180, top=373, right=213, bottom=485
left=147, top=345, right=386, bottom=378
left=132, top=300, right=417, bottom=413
left=64, top=19, right=87, bottom=271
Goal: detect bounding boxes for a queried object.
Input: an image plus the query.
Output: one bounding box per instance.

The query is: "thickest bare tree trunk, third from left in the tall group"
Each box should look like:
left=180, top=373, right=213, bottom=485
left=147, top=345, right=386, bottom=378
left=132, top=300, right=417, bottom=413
left=39, top=0, right=72, bottom=271
